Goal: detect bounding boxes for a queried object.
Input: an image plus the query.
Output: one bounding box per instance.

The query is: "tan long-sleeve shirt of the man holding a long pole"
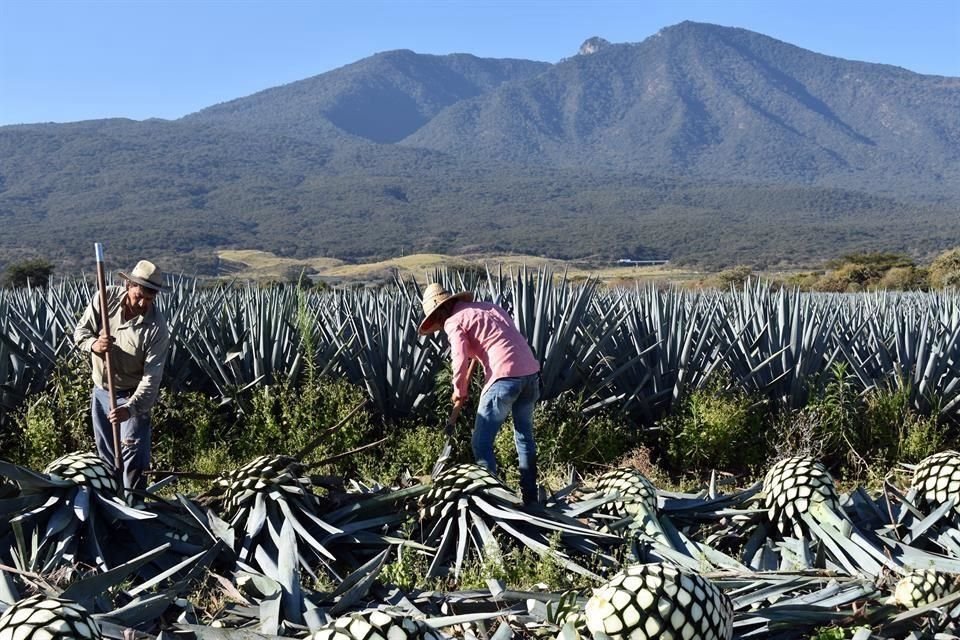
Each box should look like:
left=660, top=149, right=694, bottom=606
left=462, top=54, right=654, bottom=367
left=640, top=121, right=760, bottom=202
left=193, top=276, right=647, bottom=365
left=73, top=287, right=170, bottom=415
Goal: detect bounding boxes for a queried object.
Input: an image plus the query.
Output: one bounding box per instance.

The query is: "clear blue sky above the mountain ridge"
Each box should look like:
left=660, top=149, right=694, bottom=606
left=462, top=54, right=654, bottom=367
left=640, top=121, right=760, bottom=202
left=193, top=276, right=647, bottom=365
left=0, top=0, right=960, bottom=125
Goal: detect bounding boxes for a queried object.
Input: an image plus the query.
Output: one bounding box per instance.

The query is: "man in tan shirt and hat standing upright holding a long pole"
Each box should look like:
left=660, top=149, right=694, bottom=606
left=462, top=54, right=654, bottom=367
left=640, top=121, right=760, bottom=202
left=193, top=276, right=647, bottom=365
left=73, top=260, right=170, bottom=489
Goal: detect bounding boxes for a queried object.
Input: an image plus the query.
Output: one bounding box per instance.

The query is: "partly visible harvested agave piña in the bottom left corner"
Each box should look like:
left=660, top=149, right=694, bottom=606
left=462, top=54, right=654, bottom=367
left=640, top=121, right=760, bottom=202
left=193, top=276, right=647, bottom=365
left=0, top=594, right=103, bottom=640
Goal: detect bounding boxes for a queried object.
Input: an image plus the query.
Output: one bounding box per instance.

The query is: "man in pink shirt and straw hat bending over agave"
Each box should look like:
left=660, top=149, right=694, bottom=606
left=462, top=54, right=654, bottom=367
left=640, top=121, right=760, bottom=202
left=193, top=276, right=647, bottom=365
left=420, top=284, right=540, bottom=504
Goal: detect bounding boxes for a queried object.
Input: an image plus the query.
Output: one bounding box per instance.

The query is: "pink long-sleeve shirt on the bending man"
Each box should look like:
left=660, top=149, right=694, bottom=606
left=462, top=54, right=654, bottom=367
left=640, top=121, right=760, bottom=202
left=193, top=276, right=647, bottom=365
left=443, top=302, right=540, bottom=398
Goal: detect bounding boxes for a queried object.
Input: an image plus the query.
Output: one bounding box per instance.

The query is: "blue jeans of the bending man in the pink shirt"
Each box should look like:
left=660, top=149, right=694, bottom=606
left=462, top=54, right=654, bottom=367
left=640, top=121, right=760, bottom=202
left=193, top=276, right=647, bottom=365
left=473, top=373, right=540, bottom=503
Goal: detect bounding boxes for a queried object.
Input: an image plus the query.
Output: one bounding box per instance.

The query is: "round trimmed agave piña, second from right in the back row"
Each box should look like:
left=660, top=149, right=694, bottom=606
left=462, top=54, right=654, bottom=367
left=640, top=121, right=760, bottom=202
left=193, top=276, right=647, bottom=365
left=763, top=456, right=840, bottom=537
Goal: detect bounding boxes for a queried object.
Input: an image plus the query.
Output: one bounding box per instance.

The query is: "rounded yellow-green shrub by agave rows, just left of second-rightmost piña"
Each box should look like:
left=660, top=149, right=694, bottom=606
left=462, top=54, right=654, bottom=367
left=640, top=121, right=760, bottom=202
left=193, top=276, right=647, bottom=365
left=660, top=383, right=767, bottom=472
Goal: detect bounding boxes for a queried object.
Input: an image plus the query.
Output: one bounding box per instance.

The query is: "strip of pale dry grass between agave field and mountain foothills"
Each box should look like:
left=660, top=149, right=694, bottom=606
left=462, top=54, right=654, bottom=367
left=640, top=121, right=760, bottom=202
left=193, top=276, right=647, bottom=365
left=218, top=250, right=703, bottom=286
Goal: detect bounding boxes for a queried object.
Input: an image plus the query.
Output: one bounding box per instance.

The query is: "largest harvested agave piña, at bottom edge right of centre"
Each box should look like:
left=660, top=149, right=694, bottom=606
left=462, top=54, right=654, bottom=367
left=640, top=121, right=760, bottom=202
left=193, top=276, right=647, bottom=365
left=584, top=564, right=733, bottom=640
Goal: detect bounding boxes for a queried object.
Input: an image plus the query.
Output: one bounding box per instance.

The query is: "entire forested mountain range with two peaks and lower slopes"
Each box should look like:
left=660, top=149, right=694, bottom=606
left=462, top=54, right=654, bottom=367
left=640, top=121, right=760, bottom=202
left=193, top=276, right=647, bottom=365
left=0, top=22, right=960, bottom=272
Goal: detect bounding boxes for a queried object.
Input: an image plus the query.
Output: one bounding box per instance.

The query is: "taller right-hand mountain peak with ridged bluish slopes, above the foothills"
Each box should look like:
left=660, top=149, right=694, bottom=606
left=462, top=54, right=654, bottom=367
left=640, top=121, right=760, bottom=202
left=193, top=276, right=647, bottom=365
left=403, top=22, right=960, bottom=196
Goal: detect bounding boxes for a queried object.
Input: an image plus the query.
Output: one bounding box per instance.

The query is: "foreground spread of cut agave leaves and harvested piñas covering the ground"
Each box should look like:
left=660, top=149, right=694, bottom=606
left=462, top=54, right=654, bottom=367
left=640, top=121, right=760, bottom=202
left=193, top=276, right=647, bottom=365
left=0, top=451, right=960, bottom=640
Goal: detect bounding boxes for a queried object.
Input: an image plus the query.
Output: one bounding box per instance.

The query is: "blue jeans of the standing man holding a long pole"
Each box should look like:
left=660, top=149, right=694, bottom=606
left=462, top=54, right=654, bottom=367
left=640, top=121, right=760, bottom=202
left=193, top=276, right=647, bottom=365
left=90, top=387, right=151, bottom=490
